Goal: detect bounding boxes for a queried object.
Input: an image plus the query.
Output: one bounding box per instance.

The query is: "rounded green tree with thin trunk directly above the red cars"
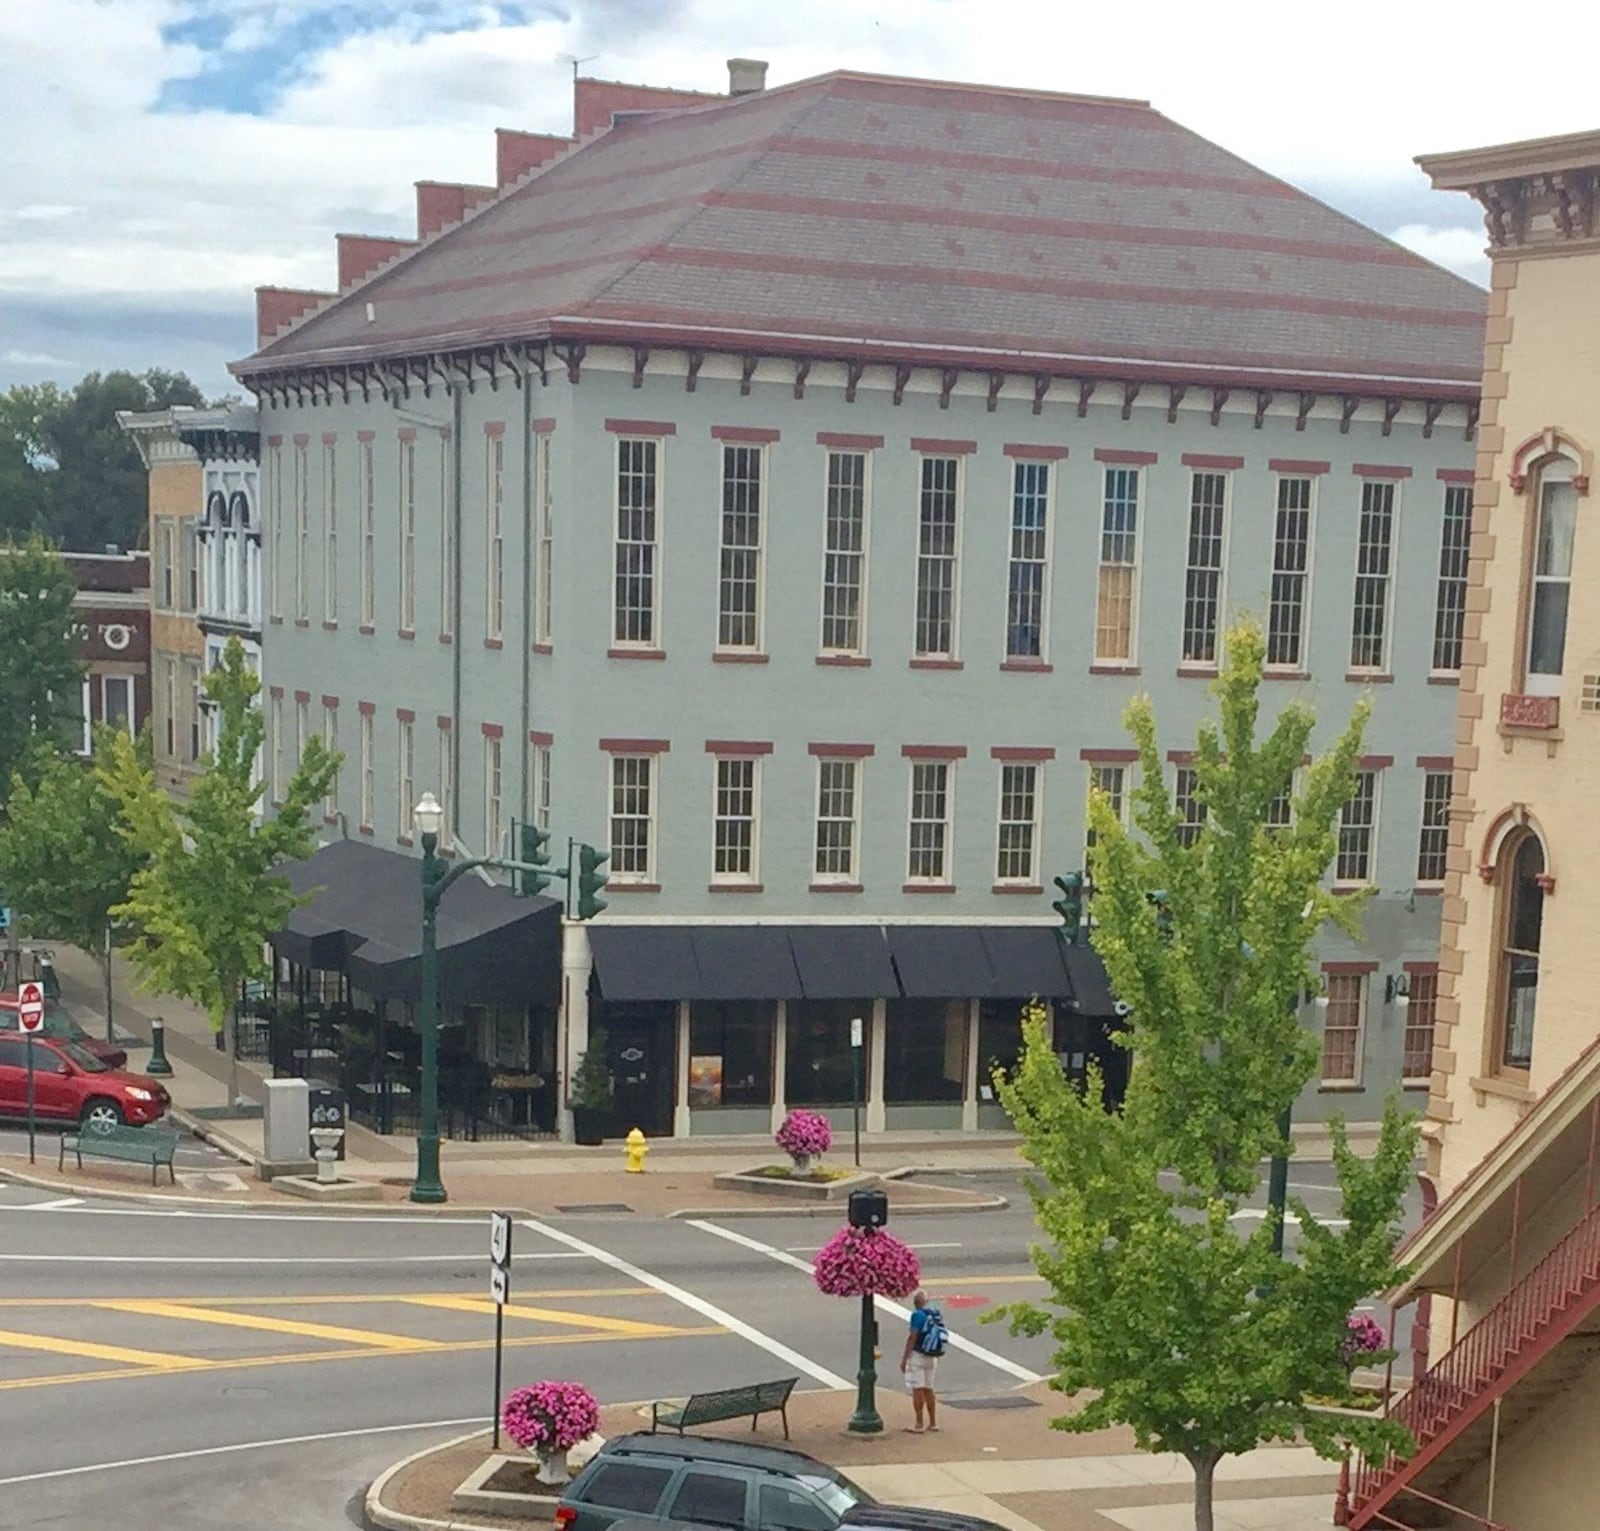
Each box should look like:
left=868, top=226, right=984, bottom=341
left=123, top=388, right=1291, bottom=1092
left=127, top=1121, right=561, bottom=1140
left=0, top=728, right=147, bottom=1037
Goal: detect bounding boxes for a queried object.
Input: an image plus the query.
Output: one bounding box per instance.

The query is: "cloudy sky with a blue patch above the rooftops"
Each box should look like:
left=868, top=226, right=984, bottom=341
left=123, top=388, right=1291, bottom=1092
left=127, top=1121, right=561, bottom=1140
left=0, top=0, right=1600, bottom=392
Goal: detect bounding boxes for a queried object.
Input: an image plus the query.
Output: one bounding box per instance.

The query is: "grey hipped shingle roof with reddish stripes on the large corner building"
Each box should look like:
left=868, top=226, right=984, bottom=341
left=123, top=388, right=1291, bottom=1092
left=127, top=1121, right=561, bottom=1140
left=237, top=74, right=1485, bottom=398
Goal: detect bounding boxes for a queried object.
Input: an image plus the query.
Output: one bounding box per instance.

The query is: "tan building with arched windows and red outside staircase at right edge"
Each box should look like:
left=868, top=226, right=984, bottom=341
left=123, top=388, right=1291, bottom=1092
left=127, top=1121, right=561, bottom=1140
left=1347, top=131, right=1600, bottom=1531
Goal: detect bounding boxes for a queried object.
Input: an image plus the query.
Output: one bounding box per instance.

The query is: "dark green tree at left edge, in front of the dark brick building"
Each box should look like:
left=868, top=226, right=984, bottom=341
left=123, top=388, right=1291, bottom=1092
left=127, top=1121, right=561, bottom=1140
left=0, top=536, right=83, bottom=799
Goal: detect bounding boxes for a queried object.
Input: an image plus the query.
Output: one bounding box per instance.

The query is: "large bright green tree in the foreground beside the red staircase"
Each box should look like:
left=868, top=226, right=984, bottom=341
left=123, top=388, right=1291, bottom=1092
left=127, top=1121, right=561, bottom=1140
left=995, top=622, right=1416, bottom=1531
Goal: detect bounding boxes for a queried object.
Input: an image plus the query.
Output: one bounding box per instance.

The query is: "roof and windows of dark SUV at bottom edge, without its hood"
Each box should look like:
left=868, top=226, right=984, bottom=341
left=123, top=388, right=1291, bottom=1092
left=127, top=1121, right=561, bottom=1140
left=555, top=1433, right=872, bottom=1531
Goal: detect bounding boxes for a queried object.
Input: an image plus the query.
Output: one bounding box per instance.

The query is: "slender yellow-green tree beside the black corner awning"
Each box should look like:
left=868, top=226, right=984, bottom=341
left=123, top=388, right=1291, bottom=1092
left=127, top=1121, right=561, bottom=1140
left=102, top=638, right=342, bottom=1101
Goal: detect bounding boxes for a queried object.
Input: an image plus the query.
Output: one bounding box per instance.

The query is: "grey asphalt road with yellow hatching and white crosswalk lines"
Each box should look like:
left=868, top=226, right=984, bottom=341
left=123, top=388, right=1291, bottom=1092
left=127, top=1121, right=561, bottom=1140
left=0, top=1166, right=1427, bottom=1531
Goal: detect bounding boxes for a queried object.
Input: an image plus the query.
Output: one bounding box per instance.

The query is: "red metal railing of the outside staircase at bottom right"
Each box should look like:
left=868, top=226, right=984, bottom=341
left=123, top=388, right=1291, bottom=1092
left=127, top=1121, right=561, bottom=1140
left=1350, top=1208, right=1600, bottom=1531
